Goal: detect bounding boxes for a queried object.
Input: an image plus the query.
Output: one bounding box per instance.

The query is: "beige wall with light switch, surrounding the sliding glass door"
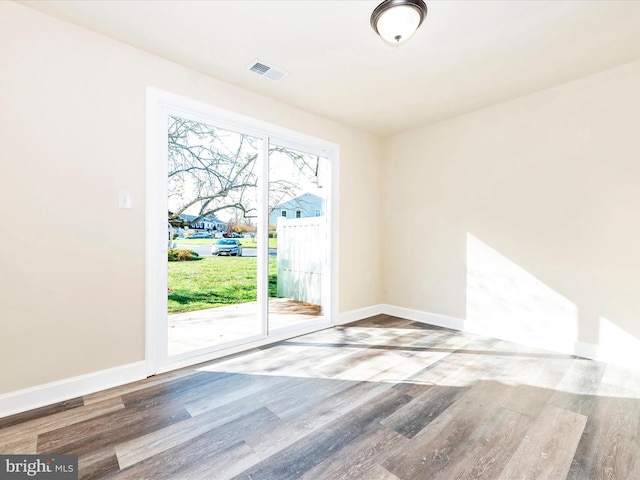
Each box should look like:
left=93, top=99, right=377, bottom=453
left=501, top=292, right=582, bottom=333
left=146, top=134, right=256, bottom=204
left=0, top=2, right=381, bottom=393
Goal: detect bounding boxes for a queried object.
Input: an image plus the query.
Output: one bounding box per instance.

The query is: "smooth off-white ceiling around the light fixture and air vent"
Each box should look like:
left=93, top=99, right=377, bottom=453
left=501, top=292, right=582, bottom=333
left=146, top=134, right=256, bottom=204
left=20, top=0, right=640, bottom=136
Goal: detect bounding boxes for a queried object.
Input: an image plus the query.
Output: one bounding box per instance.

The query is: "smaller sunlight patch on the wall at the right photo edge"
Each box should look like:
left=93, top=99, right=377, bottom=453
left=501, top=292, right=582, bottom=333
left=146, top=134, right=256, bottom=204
left=598, top=317, right=640, bottom=370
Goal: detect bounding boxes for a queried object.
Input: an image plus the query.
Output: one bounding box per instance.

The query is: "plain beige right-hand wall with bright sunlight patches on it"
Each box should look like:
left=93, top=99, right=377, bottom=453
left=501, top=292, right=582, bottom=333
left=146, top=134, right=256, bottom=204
left=383, top=62, right=640, bottom=349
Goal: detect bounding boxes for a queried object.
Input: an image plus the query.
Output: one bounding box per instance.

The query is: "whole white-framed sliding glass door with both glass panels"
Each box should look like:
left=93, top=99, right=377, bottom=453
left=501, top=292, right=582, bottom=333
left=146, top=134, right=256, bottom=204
left=147, top=91, right=336, bottom=372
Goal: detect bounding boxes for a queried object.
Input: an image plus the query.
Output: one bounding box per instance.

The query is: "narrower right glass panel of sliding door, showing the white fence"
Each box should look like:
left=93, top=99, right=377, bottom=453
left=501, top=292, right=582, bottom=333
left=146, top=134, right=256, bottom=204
left=268, top=144, right=330, bottom=332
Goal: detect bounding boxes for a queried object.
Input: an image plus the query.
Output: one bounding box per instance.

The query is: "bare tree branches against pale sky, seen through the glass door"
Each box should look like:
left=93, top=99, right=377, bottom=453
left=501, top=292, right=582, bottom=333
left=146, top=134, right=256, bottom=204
left=168, top=117, right=319, bottom=227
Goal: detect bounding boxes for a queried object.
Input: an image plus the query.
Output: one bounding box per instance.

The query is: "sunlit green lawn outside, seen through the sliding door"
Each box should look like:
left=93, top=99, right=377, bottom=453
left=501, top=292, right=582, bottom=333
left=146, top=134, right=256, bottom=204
left=167, top=256, right=277, bottom=313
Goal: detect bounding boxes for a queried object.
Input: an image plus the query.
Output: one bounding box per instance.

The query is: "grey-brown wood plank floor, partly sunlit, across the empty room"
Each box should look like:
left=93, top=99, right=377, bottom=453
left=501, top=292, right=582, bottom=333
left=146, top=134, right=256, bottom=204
left=0, top=315, right=640, bottom=480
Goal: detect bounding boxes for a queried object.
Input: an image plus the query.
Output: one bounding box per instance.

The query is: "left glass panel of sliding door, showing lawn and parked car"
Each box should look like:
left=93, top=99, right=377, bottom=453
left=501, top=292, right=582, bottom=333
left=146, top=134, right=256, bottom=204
left=167, top=116, right=265, bottom=356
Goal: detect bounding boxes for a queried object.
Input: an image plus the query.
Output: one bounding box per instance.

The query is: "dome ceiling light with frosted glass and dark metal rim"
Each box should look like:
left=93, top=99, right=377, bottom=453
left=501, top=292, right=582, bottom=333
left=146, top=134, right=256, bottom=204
left=371, top=0, right=427, bottom=46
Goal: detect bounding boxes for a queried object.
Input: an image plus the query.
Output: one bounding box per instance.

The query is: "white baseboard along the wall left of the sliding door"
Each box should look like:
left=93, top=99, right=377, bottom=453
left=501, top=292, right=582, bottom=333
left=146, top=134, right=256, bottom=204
left=0, top=361, right=147, bottom=418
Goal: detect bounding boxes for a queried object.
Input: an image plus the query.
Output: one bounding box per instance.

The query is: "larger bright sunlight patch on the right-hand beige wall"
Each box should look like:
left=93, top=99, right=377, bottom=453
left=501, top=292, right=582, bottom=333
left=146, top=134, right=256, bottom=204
left=465, top=233, right=578, bottom=353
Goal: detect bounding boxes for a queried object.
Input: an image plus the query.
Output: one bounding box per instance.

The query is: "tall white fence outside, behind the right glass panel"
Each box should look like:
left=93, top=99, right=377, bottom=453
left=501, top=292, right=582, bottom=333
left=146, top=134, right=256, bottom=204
left=276, top=217, right=327, bottom=305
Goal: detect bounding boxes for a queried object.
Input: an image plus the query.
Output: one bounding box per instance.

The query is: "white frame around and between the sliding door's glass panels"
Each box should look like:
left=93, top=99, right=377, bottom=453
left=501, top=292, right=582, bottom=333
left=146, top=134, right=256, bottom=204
left=145, top=87, right=339, bottom=375
